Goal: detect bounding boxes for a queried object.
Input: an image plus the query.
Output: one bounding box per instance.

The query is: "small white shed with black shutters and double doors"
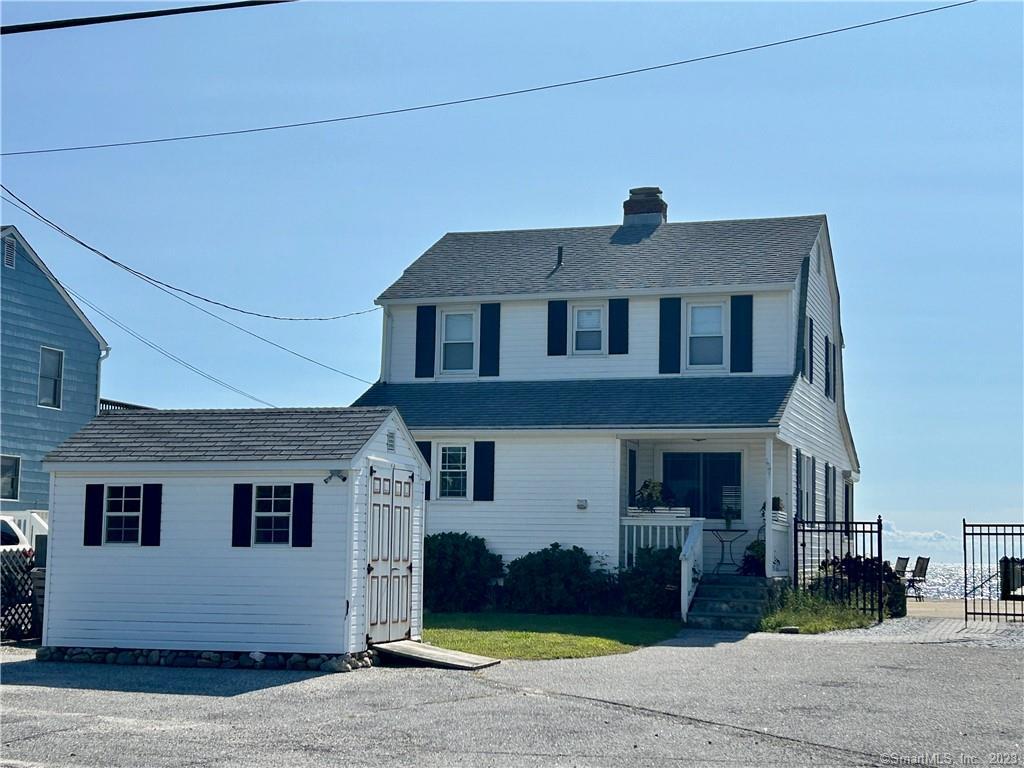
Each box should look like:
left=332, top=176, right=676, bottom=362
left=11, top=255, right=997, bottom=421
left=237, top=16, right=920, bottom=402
left=43, top=408, right=428, bottom=653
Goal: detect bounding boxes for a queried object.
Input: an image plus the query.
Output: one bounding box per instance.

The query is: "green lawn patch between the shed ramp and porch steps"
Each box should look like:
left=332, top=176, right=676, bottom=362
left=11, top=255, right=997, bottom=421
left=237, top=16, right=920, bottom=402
left=423, top=612, right=680, bottom=659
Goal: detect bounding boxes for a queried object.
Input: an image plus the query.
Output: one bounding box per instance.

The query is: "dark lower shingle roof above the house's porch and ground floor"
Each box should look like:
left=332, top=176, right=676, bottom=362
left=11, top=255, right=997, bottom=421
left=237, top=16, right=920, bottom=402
left=355, top=376, right=795, bottom=429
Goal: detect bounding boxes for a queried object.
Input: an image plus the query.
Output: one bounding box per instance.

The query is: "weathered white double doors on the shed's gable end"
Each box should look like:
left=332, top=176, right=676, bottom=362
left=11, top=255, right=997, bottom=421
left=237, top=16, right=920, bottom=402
left=367, top=463, right=413, bottom=643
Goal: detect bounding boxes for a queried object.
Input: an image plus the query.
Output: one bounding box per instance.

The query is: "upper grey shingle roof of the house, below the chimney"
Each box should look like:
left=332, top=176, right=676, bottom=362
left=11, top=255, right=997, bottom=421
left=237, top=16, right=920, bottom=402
left=380, top=215, right=825, bottom=300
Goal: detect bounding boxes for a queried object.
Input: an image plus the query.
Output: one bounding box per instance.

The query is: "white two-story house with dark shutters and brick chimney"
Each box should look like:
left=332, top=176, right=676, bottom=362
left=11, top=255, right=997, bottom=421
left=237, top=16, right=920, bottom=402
left=355, top=187, right=860, bottom=593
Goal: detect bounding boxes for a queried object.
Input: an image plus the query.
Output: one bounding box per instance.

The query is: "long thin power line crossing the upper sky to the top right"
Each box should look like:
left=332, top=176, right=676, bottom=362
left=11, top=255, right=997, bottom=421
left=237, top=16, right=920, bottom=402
left=0, top=0, right=978, bottom=158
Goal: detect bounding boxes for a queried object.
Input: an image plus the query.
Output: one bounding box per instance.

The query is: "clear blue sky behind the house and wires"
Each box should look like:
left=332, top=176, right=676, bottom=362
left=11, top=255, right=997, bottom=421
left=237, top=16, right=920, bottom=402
left=2, top=2, right=1024, bottom=557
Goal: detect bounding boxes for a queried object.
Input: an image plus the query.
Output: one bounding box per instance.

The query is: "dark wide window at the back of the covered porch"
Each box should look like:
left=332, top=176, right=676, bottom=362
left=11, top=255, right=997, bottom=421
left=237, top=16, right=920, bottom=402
left=662, top=453, right=742, bottom=519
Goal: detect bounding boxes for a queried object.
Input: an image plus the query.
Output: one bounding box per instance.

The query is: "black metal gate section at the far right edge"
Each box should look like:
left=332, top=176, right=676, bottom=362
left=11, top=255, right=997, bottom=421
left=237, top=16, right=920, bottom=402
left=964, top=519, right=1024, bottom=622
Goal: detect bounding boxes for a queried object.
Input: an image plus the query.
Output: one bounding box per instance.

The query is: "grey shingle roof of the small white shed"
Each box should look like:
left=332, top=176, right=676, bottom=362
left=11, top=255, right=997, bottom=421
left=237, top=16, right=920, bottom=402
left=46, top=408, right=391, bottom=462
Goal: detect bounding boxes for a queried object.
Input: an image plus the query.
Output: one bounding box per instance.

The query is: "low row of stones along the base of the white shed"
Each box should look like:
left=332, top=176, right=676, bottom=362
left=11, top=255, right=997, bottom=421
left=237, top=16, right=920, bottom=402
left=36, top=645, right=378, bottom=673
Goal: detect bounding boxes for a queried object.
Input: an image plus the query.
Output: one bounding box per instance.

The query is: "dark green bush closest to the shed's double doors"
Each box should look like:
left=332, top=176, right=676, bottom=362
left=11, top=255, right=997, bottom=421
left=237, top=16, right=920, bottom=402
left=423, top=531, right=502, bottom=612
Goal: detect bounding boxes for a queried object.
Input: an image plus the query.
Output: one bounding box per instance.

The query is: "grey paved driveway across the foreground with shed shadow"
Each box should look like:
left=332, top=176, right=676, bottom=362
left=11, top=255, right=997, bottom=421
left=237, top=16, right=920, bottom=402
left=0, top=620, right=1024, bottom=768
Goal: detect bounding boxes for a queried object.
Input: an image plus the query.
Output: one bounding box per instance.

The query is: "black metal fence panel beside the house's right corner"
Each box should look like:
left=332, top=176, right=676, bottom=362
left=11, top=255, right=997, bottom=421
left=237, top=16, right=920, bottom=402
left=793, top=516, right=888, bottom=622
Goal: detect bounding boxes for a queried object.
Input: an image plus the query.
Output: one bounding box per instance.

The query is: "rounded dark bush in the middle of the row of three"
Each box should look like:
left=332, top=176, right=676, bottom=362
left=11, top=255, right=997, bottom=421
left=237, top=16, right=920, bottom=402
left=502, top=544, right=616, bottom=613
